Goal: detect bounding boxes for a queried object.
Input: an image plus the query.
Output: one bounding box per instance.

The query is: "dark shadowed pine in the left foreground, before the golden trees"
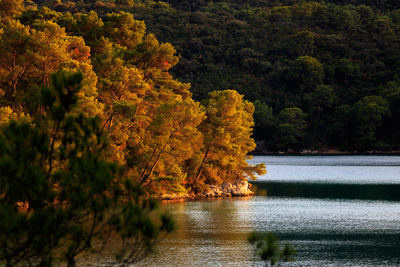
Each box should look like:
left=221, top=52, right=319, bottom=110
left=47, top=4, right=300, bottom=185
left=0, top=72, right=174, bottom=266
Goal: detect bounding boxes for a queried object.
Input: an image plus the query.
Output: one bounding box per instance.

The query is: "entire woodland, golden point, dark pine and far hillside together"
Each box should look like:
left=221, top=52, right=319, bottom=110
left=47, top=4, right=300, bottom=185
left=0, top=0, right=400, bottom=266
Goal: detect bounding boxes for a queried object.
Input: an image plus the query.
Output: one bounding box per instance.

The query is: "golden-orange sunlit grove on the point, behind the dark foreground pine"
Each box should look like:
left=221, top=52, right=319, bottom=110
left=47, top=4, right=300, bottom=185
left=0, top=0, right=264, bottom=195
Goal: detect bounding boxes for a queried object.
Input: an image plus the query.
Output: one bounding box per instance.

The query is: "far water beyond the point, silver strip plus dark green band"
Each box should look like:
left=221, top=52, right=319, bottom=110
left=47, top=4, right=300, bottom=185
left=251, top=156, right=400, bottom=201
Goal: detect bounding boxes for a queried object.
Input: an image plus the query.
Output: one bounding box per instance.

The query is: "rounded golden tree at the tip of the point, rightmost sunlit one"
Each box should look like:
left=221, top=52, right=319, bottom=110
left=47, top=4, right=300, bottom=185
left=192, top=90, right=265, bottom=189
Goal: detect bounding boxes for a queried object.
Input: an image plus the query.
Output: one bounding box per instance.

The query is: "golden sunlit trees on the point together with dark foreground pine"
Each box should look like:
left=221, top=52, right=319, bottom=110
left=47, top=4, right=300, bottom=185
left=0, top=0, right=265, bottom=266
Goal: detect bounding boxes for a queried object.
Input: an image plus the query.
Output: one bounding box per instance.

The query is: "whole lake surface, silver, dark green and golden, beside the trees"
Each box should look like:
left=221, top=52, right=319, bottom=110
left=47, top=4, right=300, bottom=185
left=91, top=156, right=400, bottom=266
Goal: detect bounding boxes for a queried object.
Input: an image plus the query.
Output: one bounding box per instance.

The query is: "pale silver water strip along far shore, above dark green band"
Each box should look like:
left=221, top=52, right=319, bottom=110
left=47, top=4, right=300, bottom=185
left=250, top=156, right=400, bottom=184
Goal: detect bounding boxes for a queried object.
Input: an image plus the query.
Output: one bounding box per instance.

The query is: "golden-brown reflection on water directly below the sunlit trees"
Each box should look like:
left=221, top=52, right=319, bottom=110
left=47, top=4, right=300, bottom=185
left=139, top=198, right=253, bottom=266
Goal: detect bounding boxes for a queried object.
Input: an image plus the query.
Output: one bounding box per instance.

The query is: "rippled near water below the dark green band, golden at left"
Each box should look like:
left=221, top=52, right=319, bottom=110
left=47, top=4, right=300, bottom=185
left=140, top=196, right=400, bottom=266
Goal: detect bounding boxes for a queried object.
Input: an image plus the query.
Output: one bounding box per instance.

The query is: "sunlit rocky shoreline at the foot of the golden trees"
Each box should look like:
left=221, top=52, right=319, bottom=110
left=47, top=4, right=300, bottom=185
left=159, top=181, right=254, bottom=200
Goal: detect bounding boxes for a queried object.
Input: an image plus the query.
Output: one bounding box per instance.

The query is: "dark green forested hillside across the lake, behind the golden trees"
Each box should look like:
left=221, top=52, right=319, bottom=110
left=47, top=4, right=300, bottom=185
left=32, top=0, right=400, bottom=151
